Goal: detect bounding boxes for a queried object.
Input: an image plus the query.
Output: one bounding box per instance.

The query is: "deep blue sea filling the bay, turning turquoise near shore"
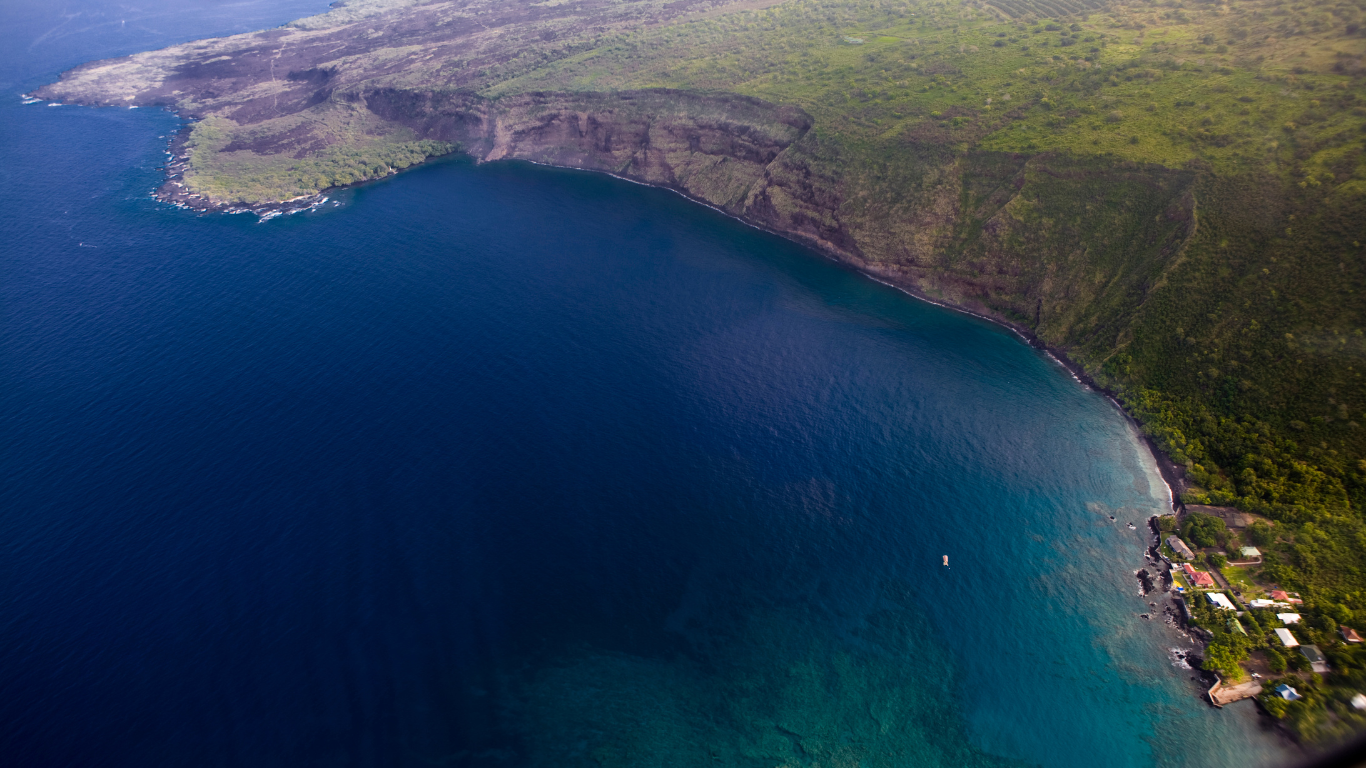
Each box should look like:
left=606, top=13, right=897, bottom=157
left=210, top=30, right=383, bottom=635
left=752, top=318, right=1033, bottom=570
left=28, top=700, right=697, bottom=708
left=0, top=0, right=1284, bottom=768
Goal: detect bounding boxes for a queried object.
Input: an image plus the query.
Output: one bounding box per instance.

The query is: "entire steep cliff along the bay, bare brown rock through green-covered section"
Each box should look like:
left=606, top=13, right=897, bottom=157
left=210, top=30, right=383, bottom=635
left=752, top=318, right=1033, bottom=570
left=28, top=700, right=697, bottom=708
left=357, top=89, right=1194, bottom=347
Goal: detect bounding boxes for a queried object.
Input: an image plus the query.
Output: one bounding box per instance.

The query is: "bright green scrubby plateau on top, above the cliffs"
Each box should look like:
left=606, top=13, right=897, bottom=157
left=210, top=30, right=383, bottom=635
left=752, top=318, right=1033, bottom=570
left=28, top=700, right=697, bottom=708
left=486, top=0, right=1366, bottom=179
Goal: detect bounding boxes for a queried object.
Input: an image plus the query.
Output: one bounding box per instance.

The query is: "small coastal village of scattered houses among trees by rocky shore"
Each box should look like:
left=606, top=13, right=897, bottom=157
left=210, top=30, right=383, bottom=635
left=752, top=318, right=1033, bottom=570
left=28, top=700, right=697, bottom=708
left=1138, top=504, right=1366, bottom=734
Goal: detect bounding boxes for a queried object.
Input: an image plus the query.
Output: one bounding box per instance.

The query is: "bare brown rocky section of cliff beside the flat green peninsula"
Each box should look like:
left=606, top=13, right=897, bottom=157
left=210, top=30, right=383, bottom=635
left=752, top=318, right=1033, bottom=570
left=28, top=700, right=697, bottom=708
left=363, top=90, right=861, bottom=256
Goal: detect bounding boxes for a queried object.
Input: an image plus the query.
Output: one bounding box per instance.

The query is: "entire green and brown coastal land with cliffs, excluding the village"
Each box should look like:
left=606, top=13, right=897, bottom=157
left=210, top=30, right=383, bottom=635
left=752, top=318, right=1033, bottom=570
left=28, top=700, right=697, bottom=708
left=32, top=0, right=1366, bottom=738
